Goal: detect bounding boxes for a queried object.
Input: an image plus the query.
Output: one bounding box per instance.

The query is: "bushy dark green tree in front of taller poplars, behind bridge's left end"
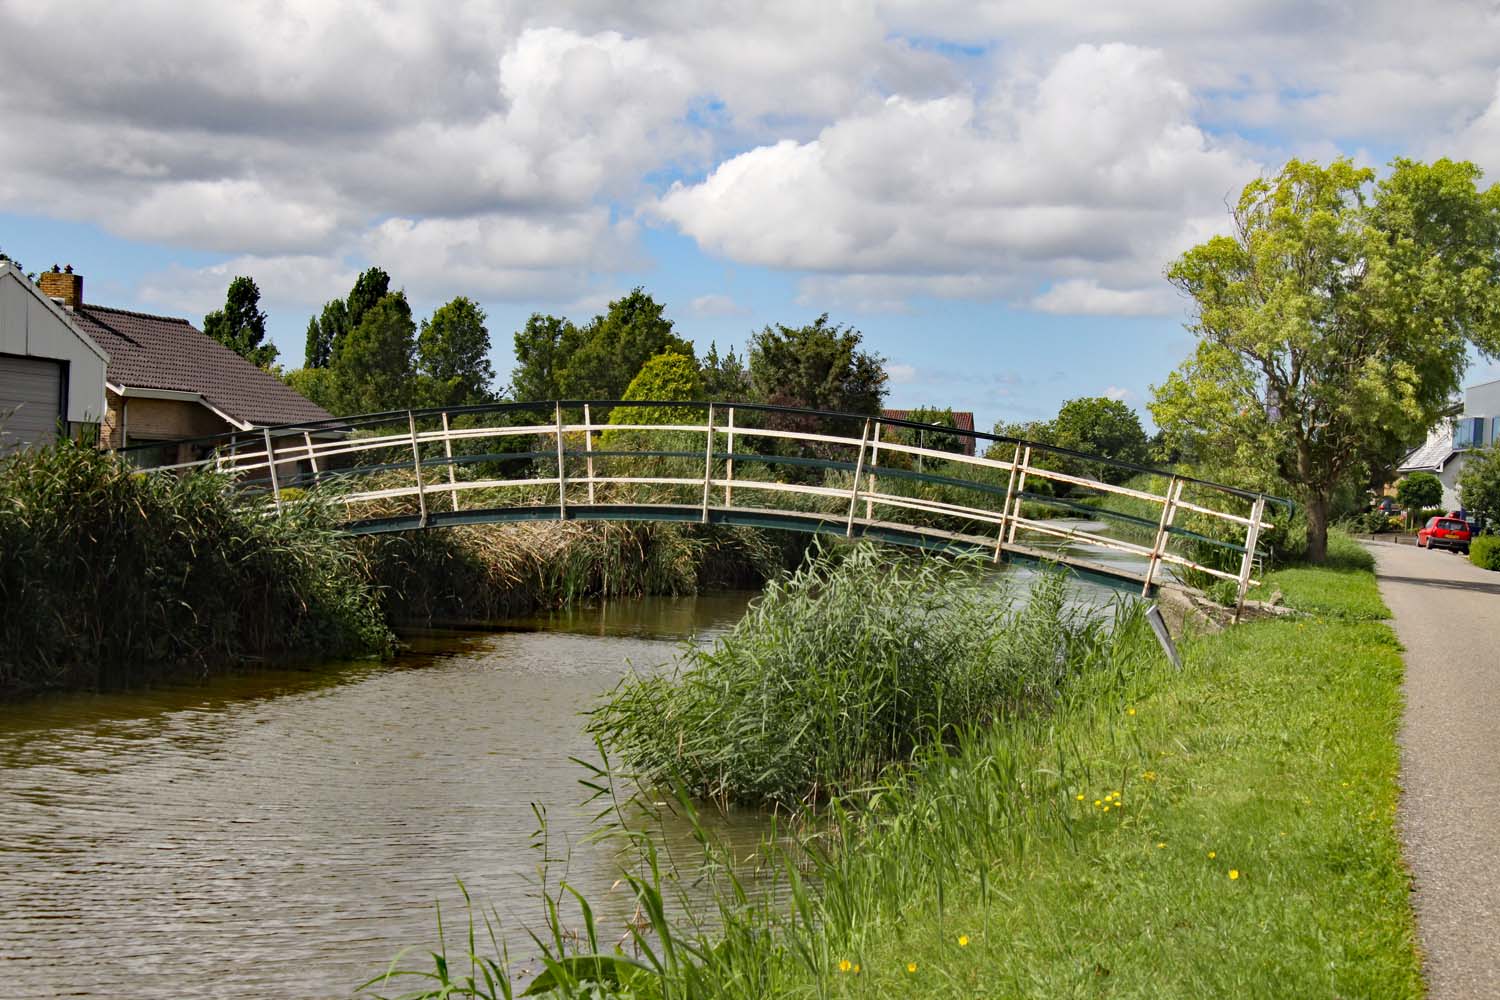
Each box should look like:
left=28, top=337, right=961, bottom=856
left=332, top=292, right=417, bottom=414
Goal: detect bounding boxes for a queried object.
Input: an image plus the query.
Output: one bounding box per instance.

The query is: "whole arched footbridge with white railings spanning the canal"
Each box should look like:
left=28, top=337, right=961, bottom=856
left=123, top=400, right=1290, bottom=614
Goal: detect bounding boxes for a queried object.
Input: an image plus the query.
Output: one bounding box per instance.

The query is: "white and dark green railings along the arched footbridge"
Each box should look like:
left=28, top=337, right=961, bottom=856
left=123, top=400, right=1290, bottom=617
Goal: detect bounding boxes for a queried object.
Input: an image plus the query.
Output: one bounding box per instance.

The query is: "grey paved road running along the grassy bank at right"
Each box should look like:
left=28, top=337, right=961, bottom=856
left=1370, top=544, right=1500, bottom=1000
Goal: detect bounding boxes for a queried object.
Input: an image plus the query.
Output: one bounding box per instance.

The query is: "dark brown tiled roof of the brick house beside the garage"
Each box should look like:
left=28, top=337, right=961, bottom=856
left=74, top=304, right=332, bottom=424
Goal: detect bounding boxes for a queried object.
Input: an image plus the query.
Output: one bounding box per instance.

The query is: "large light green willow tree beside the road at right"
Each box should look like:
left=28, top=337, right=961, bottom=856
left=1151, top=159, right=1500, bottom=561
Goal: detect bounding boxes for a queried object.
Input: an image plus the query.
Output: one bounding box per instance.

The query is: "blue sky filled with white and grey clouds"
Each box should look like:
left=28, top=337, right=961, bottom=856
left=0, top=0, right=1500, bottom=424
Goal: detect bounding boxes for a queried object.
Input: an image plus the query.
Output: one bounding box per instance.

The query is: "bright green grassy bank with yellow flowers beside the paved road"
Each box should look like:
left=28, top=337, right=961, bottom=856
left=368, top=535, right=1422, bottom=1000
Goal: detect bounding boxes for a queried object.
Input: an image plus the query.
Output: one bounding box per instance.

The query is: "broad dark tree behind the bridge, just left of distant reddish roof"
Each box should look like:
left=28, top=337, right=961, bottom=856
left=750, top=313, right=887, bottom=417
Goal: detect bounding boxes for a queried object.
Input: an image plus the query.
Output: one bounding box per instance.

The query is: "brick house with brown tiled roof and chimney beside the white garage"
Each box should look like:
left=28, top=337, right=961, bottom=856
left=28, top=267, right=332, bottom=463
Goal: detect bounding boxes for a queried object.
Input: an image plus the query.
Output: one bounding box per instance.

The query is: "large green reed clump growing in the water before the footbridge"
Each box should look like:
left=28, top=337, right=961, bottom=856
left=590, top=544, right=1103, bottom=807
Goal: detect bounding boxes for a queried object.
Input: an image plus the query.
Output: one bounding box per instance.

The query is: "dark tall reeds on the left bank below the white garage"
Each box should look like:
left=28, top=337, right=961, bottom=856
left=0, top=441, right=390, bottom=690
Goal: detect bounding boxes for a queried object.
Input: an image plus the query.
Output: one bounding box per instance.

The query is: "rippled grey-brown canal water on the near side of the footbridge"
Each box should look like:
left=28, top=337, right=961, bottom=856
left=0, top=594, right=759, bottom=1000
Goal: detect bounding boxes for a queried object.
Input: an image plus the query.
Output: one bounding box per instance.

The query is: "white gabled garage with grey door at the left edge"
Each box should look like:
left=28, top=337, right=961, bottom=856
left=0, top=261, right=110, bottom=453
